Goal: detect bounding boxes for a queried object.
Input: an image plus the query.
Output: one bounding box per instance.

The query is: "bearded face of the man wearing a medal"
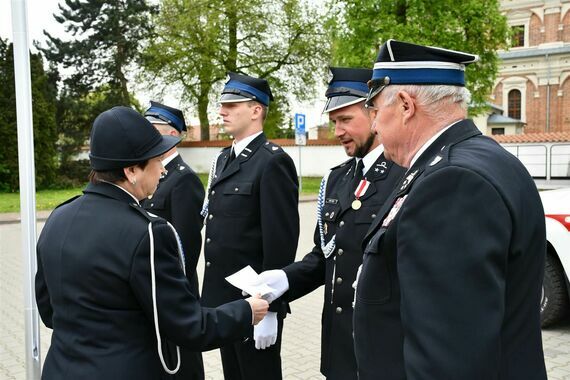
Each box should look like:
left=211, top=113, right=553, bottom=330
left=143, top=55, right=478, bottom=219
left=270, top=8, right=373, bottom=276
left=329, top=103, right=378, bottom=158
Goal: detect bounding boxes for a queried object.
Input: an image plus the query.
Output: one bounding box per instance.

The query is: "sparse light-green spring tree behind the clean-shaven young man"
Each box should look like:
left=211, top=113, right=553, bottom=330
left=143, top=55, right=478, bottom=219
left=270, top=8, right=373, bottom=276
left=143, top=0, right=329, bottom=140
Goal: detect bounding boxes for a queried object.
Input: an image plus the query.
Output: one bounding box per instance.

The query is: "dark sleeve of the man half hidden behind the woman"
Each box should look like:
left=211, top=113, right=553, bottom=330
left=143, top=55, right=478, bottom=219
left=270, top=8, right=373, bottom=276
left=170, top=172, right=204, bottom=280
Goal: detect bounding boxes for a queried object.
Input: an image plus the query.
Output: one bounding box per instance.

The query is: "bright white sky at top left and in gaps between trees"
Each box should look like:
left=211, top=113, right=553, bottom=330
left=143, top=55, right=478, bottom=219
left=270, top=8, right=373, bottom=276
left=0, top=0, right=326, bottom=131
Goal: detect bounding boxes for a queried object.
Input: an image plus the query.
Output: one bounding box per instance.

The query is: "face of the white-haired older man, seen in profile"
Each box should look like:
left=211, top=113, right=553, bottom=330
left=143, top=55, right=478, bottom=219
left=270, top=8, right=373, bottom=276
left=369, top=93, right=406, bottom=165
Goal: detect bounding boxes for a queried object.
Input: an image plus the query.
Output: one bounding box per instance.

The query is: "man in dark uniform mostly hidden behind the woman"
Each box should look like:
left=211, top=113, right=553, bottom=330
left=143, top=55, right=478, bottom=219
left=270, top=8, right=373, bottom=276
left=142, top=101, right=204, bottom=380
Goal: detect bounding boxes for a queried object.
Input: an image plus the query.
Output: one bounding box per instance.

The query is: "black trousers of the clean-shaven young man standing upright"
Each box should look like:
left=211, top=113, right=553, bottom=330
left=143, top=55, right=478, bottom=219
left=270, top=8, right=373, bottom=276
left=220, top=317, right=283, bottom=380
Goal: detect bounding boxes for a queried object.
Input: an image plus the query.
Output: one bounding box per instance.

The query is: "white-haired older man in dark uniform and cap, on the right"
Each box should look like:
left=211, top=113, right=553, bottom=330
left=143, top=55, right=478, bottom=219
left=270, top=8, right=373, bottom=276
left=354, top=40, right=546, bottom=380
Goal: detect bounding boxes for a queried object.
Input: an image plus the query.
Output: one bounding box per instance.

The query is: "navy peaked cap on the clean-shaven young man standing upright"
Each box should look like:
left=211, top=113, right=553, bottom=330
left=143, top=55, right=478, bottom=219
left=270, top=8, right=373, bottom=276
left=220, top=72, right=273, bottom=106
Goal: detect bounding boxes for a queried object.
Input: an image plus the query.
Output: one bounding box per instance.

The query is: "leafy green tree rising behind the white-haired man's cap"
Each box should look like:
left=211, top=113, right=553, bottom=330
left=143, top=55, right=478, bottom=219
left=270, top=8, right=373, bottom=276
left=330, top=0, right=510, bottom=113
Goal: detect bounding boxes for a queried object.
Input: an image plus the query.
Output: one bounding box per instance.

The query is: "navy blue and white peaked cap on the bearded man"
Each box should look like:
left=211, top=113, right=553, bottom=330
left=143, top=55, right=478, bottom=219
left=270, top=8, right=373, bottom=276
left=323, top=67, right=372, bottom=113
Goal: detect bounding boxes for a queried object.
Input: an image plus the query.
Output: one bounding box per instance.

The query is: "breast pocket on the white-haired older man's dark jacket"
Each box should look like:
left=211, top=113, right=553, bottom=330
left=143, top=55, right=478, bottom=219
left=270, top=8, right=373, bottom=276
left=356, top=230, right=392, bottom=305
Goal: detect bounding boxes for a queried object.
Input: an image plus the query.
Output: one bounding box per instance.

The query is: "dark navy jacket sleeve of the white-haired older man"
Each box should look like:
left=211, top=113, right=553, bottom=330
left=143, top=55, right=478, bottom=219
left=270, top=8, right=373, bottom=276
left=397, top=167, right=512, bottom=380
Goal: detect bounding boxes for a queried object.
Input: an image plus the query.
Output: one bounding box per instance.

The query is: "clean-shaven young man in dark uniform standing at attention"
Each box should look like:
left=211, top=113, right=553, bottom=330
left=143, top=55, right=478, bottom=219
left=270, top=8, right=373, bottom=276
left=201, top=73, right=299, bottom=380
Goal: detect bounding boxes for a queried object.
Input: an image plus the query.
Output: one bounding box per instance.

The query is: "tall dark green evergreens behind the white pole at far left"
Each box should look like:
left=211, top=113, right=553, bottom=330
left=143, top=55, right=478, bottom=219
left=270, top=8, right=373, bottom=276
left=0, top=38, right=57, bottom=191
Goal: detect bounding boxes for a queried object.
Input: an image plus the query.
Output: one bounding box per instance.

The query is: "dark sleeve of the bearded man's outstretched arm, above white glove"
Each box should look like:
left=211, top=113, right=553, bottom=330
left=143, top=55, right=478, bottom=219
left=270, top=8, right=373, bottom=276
left=283, top=225, right=326, bottom=301
